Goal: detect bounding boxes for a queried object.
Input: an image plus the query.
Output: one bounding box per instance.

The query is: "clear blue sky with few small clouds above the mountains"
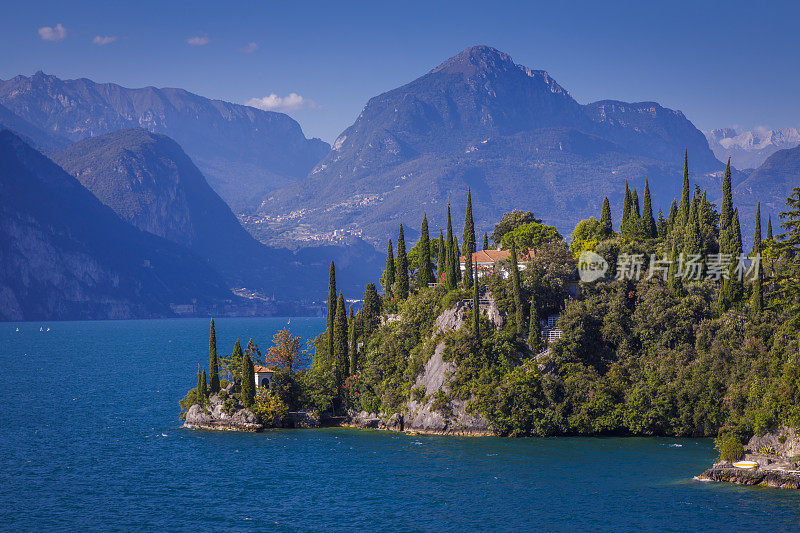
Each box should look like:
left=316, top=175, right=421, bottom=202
left=0, top=0, right=800, bottom=141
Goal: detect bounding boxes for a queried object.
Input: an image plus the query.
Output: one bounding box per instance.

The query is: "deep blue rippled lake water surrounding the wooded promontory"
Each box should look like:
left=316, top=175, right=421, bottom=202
left=0, top=318, right=800, bottom=532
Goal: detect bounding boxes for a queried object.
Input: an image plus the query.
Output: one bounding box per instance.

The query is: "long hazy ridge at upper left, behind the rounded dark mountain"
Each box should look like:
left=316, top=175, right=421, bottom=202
left=0, top=72, right=329, bottom=210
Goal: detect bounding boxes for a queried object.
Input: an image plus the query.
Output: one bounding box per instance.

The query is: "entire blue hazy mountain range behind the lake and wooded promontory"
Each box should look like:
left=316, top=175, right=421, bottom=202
left=0, top=46, right=800, bottom=320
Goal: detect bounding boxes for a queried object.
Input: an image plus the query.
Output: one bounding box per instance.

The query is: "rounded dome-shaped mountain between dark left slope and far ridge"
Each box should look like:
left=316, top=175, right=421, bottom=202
left=53, top=128, right=380, bottom=301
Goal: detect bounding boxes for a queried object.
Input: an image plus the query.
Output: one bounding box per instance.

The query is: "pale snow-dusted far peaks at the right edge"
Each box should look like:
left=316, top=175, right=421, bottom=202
left=704, top=127, right=800, bottom=169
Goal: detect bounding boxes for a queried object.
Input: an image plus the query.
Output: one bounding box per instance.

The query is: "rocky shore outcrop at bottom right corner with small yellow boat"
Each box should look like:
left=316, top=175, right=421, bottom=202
left=698, top=427, right=800, bottom=489
